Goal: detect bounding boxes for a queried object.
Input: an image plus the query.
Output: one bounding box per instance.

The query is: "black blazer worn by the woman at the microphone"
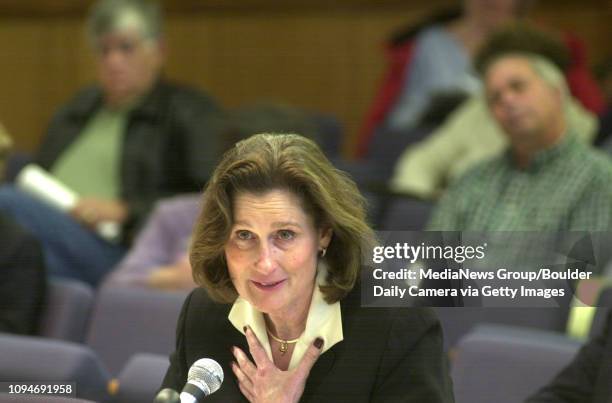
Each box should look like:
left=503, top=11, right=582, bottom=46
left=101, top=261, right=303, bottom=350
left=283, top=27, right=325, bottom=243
left=162, top=287, right=454, bottom=403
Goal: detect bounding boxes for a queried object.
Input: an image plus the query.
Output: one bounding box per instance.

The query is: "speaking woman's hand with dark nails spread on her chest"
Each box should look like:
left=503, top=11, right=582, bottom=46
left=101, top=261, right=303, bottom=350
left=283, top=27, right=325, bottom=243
left=232, top=327, right=323, bottom=403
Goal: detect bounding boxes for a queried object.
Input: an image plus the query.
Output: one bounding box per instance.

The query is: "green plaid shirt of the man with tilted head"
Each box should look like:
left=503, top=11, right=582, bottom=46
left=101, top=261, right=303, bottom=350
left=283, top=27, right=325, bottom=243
left=428, top=135, right=612, bottom=231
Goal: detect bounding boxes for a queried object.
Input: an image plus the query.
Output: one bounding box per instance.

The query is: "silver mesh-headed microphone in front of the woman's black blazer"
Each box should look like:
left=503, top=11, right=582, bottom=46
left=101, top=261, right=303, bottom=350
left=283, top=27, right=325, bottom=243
left=180, top=358, right=223, bottom=403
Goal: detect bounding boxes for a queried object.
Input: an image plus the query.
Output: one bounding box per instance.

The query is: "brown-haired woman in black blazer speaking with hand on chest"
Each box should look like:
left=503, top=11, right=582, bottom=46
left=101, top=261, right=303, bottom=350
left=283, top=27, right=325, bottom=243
left=163, top=134, right=453, bottom=403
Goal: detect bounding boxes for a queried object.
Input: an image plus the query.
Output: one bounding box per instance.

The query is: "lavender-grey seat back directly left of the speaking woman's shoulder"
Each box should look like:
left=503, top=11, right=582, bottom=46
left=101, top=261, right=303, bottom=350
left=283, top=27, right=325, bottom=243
left=86, top=287, right=186, bottom=375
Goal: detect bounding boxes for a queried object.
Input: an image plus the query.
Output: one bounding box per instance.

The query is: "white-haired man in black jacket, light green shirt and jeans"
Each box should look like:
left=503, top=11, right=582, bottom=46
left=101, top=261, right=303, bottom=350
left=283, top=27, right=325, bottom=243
left=0, top=0, right=223, bottom=285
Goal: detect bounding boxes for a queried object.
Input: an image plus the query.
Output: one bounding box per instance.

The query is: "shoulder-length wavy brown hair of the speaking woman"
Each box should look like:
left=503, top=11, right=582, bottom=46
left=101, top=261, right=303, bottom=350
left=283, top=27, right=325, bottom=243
left=190, top=133, right=374, bottom=303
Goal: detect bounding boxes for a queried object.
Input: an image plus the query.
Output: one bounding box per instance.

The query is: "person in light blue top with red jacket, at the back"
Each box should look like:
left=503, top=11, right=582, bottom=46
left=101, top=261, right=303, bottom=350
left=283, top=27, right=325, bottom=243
left=356, top=0, right=605, bottom=158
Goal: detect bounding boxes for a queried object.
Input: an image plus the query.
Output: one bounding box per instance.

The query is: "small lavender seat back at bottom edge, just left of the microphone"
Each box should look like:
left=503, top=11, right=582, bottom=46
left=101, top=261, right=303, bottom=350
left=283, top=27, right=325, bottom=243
left=115, top=354, right=169, bottom=403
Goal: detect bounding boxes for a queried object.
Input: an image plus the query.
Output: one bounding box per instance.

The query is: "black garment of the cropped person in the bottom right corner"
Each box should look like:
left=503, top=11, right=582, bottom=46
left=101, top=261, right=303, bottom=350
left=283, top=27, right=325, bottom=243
left=527, top=308, right=612, bottom=403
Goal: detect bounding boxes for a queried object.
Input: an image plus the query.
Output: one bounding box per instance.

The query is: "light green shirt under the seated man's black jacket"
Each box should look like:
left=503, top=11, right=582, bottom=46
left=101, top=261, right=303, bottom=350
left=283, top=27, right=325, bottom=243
left=51, top=108, right=128, bottom=199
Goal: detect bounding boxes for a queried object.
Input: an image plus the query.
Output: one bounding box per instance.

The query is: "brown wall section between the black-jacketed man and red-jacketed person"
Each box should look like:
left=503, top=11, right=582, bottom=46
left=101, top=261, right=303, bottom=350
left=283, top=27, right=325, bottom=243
left=167, top=9, right=448, bottom=154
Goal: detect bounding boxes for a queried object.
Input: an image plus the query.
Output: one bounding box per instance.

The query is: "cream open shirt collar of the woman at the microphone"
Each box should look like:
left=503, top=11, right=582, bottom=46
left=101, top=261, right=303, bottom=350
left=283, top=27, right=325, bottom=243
left=228, top=263, right=343, bottom=369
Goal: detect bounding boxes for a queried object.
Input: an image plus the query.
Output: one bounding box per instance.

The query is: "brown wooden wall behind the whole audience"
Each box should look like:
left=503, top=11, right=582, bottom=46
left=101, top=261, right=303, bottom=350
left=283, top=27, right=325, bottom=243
left=0, top=0, right=612, bottom=155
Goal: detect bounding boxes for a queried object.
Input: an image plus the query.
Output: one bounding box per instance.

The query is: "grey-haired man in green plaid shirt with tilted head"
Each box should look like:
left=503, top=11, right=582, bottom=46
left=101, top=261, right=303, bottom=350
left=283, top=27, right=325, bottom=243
left=428, top=53, right=612, bottom=231
